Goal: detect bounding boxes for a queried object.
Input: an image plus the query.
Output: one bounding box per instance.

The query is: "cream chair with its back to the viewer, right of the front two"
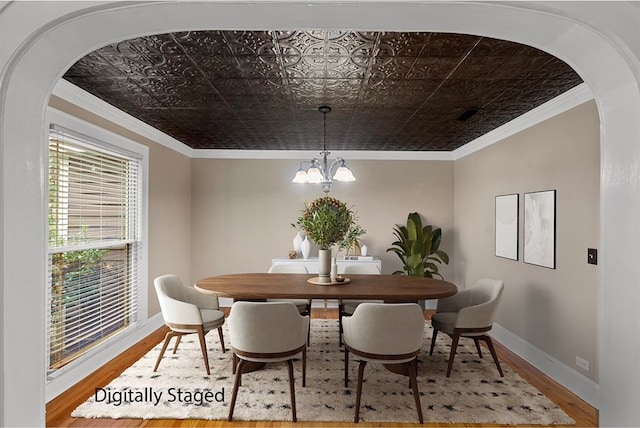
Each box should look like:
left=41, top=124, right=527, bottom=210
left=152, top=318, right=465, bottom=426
left=343, top=303, right=425, bottom=423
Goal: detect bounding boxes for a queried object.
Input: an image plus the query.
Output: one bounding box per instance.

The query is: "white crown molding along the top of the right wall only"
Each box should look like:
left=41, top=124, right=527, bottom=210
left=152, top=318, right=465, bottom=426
left=452, top=83, right=593, bottom=161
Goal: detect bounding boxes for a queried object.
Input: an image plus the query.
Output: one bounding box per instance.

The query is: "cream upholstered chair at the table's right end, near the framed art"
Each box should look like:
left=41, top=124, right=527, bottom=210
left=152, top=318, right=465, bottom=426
left=429, top=278, right=504, bottom=377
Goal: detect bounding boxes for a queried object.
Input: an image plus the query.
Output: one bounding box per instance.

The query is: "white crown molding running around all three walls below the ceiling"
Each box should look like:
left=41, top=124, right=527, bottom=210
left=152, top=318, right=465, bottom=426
left=53, top=79, right=593, bottom=161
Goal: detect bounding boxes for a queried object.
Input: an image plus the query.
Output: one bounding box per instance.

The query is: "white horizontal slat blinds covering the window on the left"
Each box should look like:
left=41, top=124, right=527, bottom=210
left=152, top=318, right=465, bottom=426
left=48, top=125, right=142, bottom=370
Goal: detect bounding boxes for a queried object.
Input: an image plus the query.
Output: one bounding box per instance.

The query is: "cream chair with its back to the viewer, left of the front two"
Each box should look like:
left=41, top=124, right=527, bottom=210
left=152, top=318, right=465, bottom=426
left=227, top=302, right=309, bottom=422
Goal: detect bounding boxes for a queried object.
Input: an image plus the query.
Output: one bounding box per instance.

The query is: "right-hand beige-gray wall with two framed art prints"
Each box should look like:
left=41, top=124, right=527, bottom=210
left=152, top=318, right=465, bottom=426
left=454, top=102, right=600, bottom=382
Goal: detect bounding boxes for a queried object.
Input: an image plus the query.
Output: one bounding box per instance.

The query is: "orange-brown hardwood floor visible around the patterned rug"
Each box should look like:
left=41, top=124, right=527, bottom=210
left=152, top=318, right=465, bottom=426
left=46, top=309, right=598, bottom=428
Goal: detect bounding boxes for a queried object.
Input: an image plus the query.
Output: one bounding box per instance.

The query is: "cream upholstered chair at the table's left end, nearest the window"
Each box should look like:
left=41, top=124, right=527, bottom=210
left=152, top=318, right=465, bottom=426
left=153, top=274, right=226, bottom=374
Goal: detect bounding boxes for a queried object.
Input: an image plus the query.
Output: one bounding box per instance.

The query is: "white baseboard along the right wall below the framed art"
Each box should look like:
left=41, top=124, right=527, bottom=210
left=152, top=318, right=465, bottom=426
left=491, top=324, right=599, bottom=409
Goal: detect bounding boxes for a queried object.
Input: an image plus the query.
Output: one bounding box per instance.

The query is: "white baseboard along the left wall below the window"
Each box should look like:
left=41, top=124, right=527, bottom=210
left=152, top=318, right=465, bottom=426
left=45, top=313, right=164, bottom=403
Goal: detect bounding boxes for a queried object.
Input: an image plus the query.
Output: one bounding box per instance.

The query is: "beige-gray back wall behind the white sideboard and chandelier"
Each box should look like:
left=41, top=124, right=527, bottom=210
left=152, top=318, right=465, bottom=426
left=191, top=159, right=453, bottom=279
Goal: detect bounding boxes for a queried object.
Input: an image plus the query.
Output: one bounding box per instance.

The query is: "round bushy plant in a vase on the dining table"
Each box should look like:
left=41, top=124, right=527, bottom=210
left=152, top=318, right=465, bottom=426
left=296, top=196, right=355, bottom=283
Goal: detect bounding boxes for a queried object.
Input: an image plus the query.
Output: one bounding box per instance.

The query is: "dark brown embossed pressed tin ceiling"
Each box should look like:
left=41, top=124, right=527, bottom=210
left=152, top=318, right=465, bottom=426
left=63, top=31, right=582, bottom=151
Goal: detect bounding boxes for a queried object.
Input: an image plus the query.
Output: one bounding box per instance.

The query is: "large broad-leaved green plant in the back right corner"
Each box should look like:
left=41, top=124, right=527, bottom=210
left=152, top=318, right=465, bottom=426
left=387, top=212, right=449, bottom=279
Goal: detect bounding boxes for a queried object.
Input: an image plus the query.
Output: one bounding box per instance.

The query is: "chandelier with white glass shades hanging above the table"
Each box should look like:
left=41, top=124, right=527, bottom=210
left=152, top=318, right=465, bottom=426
left=292, top=106, right=356, bottom=193
